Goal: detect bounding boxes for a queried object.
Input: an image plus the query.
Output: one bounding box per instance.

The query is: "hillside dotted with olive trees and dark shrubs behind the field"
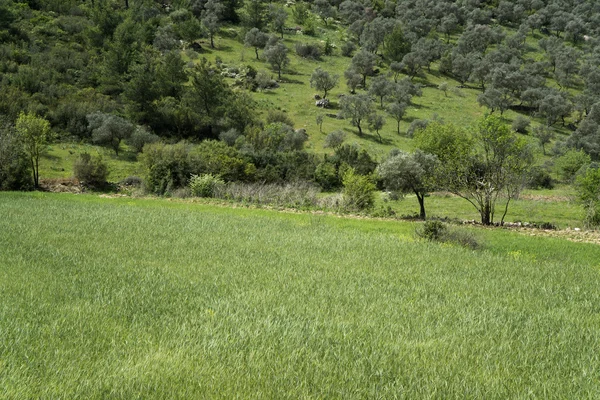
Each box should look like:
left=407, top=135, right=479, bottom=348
left=0, top=0, right=600, bottom=225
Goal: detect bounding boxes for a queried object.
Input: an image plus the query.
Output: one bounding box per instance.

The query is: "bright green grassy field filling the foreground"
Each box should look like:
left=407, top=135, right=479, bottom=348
left=0, top=193, right=600, bottom=399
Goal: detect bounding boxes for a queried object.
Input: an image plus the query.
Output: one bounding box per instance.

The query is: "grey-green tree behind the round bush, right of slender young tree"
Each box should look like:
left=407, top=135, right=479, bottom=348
left=87, top=112, right=135, bottom=157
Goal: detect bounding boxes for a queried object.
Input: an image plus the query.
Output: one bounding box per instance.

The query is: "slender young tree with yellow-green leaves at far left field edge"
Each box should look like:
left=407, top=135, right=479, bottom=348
left=15, top=111, right=54, bottom=188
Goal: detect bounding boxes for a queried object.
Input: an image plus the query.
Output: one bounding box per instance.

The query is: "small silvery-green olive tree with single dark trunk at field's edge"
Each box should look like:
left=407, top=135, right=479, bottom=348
left=377, top=150, right=438, bottom=219
